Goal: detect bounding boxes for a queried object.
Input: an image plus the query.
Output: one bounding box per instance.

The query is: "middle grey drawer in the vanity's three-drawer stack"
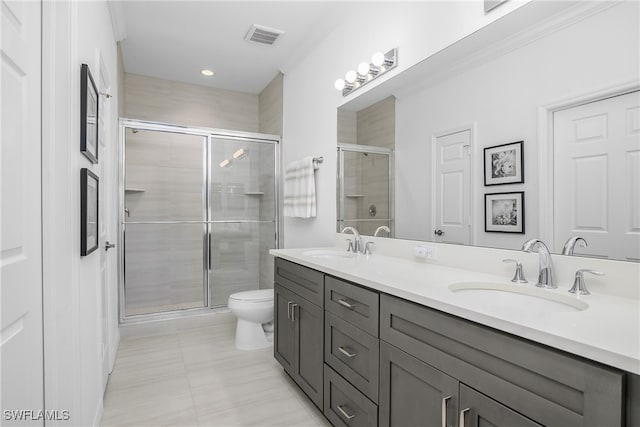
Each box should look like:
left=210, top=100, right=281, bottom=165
left=324, top=313, right=380, bottom=403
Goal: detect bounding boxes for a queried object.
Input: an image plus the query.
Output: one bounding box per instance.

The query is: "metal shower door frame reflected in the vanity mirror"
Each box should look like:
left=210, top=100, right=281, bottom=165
left=336, top=143, right=395, bottom=237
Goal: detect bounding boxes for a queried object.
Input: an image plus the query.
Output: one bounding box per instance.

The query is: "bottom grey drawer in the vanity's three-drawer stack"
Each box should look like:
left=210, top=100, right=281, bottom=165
left=324, top=365, right=378, bottom=427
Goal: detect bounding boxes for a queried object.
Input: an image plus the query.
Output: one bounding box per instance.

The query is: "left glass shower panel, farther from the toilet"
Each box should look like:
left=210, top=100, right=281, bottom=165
left=124, top=128, right=207, bottom=316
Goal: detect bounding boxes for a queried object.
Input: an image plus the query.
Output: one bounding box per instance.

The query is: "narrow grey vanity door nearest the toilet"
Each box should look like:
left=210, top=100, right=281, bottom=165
left=273, top=283, right=296, bottom=376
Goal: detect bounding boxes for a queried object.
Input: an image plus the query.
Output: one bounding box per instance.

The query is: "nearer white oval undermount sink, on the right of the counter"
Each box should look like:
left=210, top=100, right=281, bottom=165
left=449, top=282, right=589, bottom=313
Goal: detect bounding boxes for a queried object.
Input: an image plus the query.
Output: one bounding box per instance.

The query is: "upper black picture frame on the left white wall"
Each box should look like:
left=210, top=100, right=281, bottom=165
left=80, top=64, right=99, bottom=164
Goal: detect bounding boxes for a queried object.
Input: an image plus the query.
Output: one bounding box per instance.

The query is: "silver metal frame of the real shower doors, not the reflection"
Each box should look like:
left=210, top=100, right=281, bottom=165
left=116, top=118, right=282, bottom=324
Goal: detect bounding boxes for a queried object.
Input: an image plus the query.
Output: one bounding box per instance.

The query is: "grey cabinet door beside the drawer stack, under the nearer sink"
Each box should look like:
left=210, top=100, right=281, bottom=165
left=379, top=341, right=458, bottom=427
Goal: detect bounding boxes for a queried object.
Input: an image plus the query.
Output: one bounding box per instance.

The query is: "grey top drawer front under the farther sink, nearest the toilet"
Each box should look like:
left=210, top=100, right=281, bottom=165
left=274, top=258, right=324, bottom=307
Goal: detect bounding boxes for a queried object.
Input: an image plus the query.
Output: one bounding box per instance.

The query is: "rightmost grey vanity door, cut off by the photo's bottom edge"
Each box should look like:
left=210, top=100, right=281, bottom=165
left=460, top=384, right=542, bottom=427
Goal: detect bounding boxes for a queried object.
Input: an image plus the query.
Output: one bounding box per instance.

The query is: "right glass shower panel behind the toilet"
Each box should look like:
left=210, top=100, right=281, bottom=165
left=209, top=137, right=276, bottom=307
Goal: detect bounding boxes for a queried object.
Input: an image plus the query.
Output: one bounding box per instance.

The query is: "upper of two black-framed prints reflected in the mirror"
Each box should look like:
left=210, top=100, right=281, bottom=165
left=484, top=141, right=524, bottom=186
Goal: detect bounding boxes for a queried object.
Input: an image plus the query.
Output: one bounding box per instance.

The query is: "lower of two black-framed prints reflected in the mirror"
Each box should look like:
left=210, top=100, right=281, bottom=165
left=484, top=191, right=524, bottom=234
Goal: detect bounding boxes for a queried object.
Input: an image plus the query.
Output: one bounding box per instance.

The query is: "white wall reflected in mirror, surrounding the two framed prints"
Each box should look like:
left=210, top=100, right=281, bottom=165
left=396, top=2, right=640, bottom=249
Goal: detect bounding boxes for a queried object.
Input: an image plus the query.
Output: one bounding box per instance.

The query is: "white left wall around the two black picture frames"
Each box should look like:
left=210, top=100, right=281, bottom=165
left=42, top=1, right=118, bottom=426
